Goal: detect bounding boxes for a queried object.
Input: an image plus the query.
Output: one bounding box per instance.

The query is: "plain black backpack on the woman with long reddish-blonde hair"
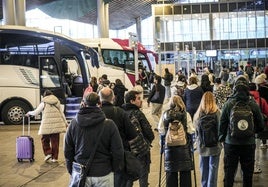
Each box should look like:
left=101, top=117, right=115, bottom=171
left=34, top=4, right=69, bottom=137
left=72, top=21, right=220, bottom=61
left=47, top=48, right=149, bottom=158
left=197, top=113, right=218, bottom=147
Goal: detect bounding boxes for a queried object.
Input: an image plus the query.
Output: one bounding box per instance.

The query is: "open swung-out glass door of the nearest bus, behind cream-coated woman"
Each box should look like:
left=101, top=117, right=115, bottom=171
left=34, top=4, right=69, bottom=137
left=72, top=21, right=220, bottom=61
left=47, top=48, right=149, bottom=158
left=39, top=56, right=65, bottom=104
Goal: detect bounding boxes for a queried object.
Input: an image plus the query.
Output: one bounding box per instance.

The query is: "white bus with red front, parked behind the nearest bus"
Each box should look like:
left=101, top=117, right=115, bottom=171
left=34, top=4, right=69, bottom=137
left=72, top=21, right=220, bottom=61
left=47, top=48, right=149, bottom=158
left=77, top=38, right=158, bottom=89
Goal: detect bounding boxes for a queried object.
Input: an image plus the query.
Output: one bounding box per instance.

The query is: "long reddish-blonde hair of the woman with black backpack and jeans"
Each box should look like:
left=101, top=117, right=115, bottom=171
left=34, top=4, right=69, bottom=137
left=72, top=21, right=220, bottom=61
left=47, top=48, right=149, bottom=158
left=197, top=91, right=218, bottom=114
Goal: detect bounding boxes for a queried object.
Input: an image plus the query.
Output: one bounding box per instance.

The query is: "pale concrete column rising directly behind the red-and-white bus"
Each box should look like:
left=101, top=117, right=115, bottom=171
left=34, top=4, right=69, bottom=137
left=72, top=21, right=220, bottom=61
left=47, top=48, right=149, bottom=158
left=97, top=0, right=109, bottom=38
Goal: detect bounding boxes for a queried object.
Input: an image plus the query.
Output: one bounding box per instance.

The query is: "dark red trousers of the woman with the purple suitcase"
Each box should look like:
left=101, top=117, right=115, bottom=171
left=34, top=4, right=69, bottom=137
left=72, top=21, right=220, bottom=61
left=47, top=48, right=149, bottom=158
left=41, top=133, right=60, bottom=160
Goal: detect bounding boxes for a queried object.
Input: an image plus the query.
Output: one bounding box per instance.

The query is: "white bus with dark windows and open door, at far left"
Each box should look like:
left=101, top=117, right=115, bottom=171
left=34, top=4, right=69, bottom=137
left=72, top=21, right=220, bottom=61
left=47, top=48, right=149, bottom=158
left=0, top=26, right=98, bottom=124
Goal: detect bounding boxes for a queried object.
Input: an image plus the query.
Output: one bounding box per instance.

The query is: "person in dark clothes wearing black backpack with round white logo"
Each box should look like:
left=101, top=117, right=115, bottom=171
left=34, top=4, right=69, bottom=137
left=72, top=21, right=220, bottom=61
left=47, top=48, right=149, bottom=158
left=219, top=75, right=264, bottom=187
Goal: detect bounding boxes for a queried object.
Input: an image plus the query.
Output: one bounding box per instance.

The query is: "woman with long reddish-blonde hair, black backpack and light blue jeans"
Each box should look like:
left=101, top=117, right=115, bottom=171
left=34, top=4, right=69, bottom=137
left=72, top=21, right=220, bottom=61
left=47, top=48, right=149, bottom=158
left=193, top=91, right=222, bottom=187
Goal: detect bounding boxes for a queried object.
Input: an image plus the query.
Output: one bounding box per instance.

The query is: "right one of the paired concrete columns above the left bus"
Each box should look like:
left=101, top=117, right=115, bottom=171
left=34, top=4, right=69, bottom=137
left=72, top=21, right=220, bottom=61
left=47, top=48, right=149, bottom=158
left=15, top=0, right=26, bottom=26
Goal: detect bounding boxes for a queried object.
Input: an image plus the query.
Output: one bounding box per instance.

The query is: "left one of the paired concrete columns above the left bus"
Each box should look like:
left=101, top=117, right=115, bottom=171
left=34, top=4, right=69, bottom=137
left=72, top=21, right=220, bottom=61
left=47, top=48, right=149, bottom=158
left=2, top=0, right=15, bottom=25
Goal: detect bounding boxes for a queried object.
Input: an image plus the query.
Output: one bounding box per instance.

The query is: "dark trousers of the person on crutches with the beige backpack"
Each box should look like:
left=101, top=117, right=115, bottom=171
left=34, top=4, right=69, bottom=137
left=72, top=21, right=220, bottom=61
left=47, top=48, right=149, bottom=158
left=166, top=171, right=192, bottom=187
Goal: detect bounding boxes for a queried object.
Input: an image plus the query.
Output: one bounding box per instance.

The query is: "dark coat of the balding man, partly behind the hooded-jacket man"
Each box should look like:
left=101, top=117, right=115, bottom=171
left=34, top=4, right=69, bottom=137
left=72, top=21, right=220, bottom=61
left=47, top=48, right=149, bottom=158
left=101, top=102, right=137, bottom=150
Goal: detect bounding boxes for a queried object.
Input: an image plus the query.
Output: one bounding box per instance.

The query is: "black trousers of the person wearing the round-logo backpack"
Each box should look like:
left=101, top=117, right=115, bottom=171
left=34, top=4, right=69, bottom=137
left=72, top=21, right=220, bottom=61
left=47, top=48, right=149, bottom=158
left=224, top=144, right=256, bottom=187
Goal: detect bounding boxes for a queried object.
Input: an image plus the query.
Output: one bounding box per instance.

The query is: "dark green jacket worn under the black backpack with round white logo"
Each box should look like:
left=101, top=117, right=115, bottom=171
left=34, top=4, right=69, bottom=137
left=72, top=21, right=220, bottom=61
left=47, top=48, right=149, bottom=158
left=219, top=92, right=264, bottom=145
